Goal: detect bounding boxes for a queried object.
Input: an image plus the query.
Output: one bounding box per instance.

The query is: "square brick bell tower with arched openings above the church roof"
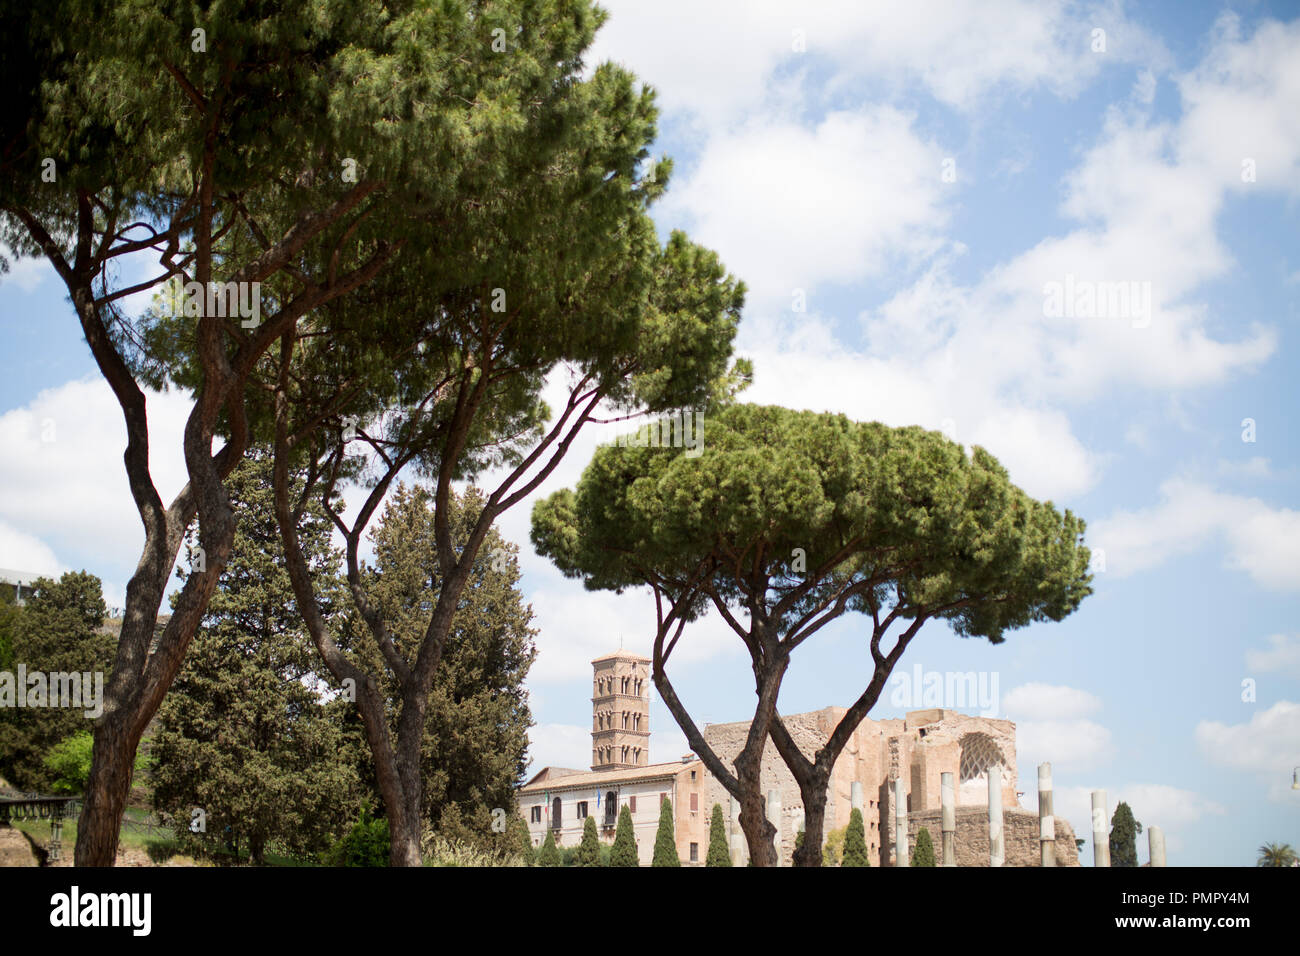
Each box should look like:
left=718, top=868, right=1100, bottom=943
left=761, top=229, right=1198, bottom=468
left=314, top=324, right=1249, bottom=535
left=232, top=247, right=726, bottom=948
left=592, top=650, right=650, bottom=770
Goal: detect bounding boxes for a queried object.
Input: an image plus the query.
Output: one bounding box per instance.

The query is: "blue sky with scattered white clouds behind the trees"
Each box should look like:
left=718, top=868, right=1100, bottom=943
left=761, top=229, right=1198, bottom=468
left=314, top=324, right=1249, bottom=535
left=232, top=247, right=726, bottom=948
left=0, top=0, right=1300, bottom=865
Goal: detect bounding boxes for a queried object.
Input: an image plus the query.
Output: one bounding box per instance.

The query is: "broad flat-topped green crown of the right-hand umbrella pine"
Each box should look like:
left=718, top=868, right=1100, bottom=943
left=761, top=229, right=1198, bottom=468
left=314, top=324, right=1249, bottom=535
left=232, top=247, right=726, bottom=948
left=532, top=402, right=1092, bottom=864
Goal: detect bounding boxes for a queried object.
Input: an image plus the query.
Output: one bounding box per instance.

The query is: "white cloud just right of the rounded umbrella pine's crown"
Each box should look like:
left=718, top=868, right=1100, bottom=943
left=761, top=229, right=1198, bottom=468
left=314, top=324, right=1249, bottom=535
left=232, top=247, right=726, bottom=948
left=1088, top=479, right=1300, bottom=591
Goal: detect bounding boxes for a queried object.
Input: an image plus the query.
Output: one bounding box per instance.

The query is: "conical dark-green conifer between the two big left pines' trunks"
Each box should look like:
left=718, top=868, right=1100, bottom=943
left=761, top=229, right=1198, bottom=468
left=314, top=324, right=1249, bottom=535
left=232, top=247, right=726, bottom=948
left=151, top=451, right=361, bottom=864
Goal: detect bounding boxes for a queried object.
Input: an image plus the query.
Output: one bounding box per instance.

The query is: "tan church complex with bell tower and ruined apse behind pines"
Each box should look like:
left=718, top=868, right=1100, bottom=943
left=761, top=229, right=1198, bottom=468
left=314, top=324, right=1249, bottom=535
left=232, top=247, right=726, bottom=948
left=519, top=650, right=1078, bottom=866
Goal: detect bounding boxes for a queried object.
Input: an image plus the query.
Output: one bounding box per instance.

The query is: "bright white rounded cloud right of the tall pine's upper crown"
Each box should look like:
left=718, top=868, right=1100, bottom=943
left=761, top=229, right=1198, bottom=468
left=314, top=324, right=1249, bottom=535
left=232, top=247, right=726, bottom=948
left=663, top=107, right=945, bottom=299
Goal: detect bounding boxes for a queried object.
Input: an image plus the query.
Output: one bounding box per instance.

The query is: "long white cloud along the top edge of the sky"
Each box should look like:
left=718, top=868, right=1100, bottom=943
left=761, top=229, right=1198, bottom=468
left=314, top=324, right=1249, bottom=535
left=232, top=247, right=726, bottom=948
left=590, top=0, right=1165, bottom=125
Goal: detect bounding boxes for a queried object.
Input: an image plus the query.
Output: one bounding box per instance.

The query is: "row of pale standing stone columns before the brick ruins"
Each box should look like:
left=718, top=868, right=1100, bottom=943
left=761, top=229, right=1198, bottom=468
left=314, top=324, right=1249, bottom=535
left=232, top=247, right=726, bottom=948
left=731, top=763, right=1165, bottom=866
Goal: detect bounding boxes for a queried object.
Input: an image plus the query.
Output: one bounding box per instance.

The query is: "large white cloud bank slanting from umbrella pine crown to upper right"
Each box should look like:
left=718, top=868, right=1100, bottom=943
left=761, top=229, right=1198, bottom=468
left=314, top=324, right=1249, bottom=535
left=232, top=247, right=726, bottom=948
left=717, top=16, right=1300, bottom=509
